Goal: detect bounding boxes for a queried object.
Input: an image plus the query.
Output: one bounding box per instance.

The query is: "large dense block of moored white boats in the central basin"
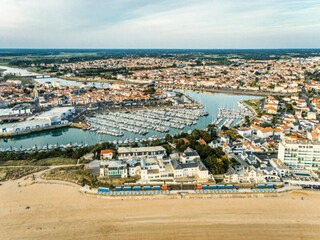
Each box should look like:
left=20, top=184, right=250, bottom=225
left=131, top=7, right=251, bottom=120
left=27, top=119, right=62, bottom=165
left=86, top=108, right=209, bottom=137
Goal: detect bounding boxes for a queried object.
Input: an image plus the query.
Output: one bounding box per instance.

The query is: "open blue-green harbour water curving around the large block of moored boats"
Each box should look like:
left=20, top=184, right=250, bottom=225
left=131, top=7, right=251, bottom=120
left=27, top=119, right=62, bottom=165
left=0, top=91, right=255, bottom=149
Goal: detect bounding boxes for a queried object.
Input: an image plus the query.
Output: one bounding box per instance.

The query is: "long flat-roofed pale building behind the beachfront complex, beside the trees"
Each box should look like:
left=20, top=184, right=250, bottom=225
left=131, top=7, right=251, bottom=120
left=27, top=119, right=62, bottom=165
left=118, top=146, right=166, bottom=160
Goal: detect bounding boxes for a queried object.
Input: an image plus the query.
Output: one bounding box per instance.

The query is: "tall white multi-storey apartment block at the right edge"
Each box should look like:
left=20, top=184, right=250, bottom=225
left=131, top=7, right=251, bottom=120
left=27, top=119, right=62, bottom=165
left=278, top=140, right=320, bottom=170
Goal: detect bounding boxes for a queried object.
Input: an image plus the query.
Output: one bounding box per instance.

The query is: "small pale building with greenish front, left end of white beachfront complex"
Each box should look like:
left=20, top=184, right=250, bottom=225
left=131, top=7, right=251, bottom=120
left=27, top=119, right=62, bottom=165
left=100, top=161, right=128, bottom=178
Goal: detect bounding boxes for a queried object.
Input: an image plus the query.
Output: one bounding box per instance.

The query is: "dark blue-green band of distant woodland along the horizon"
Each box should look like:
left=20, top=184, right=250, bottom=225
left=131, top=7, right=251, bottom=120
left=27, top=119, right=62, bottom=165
left=0, top=49, right=320, bottom=67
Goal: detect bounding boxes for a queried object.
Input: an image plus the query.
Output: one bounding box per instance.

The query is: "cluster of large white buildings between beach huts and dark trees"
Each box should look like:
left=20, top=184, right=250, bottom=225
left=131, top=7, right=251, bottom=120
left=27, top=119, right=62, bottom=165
left=100, top=146, right=211, bottom=182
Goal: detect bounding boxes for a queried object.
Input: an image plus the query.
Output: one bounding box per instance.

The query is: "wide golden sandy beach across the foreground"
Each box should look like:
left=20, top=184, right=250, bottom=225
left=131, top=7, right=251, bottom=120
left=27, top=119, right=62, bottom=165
left=0, top=181, right=320, bottom=240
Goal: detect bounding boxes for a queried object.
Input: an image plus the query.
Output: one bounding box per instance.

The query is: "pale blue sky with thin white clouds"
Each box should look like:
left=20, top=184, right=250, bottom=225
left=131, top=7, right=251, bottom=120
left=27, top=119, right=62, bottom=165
left=0, top=0, right=320, bottom=49
